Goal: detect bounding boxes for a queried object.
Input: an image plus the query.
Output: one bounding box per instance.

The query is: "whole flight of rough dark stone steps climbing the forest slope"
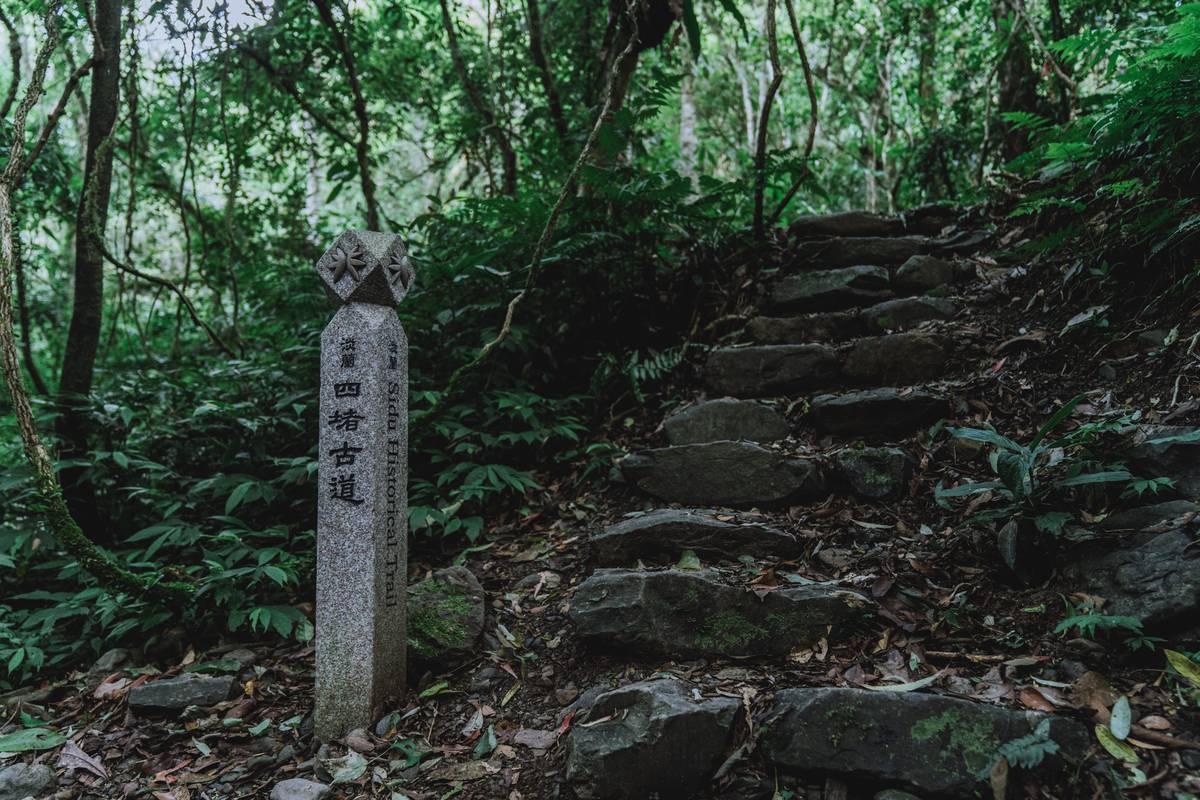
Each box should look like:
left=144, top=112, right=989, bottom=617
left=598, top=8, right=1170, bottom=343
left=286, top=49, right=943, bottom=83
left=556, top=209, right=1086, bottom=800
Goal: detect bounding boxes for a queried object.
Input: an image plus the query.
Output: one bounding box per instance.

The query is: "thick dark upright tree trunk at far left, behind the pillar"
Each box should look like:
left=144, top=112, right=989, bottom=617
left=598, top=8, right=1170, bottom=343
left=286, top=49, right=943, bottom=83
left=58, top=0, right=121, bottom=544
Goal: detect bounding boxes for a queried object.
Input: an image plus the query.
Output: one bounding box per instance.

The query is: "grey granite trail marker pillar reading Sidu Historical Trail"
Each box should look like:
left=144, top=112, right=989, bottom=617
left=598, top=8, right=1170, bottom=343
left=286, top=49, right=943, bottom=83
left=314, top=230, right=414, bottom=740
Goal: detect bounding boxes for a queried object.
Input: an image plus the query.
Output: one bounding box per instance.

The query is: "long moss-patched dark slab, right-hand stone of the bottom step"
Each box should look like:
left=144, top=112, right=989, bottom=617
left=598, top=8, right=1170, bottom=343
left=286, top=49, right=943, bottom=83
left=762, top=688, right=1088, bottom=798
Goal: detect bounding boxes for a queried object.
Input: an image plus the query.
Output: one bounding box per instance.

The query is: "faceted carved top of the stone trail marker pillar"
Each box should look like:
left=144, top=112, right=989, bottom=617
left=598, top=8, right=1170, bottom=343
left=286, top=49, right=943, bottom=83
left=317, top=230, right=415, bottom=306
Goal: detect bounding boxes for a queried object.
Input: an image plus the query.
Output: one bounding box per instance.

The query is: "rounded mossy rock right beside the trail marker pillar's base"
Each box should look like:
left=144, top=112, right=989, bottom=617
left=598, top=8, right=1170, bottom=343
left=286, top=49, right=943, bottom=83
left=408, top=566, right=487, bottom=663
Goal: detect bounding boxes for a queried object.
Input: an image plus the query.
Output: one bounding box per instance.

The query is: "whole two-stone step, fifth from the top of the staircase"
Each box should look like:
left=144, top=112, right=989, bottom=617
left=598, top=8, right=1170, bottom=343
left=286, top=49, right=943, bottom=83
left=704, top=332, right=949, bottom=397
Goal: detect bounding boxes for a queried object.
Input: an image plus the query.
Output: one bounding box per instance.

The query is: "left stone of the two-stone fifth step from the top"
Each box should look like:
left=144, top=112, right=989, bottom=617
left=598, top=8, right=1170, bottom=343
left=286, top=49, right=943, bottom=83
left=704, top=344, right=841, bottom=397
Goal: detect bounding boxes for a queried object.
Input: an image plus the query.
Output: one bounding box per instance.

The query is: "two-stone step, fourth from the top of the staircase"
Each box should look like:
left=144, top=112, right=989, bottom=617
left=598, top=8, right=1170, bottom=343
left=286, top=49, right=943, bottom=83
left=750, top=297, right=959, bottom=344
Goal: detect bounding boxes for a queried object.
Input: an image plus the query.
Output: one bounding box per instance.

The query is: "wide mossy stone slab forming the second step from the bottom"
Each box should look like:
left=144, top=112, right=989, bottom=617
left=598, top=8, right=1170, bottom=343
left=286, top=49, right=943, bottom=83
left=570, top=570, right=868, bottom=658
